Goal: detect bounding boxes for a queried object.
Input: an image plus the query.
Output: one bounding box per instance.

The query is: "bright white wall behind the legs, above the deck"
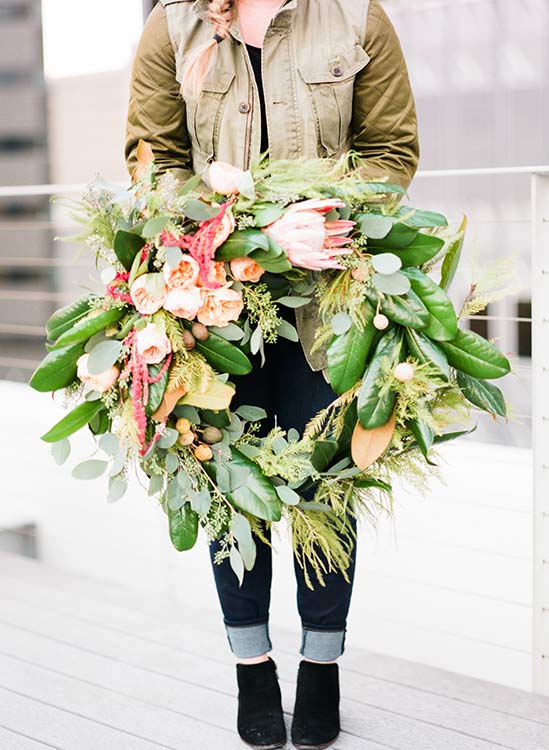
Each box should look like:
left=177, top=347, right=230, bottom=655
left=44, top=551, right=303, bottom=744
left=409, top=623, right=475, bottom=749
left=0, top=382, right=532, bottom=690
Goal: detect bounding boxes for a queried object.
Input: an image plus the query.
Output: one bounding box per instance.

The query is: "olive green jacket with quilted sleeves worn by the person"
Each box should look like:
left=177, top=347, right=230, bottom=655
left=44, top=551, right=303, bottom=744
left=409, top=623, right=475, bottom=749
left=126, top=0, right=419, bottom=369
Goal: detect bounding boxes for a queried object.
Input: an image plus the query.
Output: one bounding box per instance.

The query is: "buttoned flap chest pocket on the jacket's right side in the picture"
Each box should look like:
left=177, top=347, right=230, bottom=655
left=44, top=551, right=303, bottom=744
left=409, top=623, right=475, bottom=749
left=299, top=44, right=370, bottom=156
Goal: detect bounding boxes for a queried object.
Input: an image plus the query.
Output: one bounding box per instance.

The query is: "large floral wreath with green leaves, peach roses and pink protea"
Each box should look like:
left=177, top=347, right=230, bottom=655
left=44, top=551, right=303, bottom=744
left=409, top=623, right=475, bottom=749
left=30, top=148, right=510, bottom=585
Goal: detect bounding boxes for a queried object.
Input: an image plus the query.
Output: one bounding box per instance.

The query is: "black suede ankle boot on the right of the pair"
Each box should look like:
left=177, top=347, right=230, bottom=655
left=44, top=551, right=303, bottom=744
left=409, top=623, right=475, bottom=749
left=292, top=661, right=339, bottom=750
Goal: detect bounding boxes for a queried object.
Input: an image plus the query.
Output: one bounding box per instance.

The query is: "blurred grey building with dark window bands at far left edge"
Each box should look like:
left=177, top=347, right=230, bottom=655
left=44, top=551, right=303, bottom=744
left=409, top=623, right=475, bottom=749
left=0, top=0, right=51, bottom=378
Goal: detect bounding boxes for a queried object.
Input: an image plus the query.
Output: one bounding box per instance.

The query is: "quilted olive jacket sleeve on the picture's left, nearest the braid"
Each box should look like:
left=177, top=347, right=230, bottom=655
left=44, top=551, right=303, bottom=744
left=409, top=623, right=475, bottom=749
left=125, top=4, right=193, bottom=180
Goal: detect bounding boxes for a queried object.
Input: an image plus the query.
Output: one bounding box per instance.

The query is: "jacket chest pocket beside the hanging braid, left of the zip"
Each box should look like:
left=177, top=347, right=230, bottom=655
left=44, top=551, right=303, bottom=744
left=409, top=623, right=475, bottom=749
left=187, top=71, right=235, bottom=161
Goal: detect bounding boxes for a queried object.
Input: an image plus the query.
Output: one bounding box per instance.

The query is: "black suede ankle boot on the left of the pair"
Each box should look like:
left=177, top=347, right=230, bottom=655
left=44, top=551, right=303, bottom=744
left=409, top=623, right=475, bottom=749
left=236, top=659, right=286, bottom=750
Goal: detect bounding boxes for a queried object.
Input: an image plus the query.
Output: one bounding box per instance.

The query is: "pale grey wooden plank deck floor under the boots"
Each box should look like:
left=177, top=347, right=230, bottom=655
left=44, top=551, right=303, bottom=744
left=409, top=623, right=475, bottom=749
left=0, top=554, right=549, bottom=750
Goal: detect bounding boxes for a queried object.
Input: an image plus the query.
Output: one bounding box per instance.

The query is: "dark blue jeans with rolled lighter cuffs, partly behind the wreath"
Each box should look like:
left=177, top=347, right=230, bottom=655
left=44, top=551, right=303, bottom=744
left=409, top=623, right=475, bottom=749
left=210, top=316, right=356, bottom=661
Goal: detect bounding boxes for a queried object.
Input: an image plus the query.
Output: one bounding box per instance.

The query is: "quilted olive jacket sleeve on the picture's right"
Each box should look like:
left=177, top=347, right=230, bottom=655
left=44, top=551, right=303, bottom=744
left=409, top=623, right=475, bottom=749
left=352, top=0, right=419, bottom=188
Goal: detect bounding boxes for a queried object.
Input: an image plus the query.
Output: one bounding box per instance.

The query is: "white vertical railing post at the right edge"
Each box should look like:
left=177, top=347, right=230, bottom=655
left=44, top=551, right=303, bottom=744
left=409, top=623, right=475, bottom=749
left=531, top=174, right=549, bottom=695
